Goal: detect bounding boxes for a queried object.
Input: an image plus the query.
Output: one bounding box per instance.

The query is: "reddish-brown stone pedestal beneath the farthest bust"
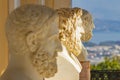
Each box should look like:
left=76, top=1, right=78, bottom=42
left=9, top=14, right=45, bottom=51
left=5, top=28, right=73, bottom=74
left=80, top=61, right=90, bottom=80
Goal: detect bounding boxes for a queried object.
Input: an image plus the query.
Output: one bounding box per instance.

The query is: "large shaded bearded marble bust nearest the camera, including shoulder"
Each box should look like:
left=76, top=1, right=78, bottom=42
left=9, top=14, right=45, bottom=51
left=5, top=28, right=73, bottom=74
left=0, top=5, right=62, bottom=80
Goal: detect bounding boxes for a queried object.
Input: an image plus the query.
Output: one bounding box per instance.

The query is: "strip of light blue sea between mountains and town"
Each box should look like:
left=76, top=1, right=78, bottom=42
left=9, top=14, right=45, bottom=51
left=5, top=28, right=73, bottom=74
left=90, top=32, right=120, bottom=44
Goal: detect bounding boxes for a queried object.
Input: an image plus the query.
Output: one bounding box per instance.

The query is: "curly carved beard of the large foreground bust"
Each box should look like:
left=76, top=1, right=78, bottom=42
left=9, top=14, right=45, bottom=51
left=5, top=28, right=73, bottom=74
left=31, top=48, right=57, bottom=78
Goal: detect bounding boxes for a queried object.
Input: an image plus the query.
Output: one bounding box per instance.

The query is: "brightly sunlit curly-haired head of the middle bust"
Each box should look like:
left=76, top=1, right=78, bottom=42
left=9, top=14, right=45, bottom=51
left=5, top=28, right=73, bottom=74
left=57, top=8, right=84, bottom=56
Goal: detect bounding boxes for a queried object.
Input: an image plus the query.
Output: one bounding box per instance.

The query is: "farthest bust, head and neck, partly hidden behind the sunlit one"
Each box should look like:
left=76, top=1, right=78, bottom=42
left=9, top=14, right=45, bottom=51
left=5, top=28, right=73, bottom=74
left=77, top=9, right=95, bottom=61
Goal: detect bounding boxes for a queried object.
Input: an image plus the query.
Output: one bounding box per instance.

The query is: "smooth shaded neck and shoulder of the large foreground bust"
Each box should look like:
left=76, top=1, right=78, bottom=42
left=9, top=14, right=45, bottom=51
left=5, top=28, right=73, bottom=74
left=0, top=54, right=43, bottom=80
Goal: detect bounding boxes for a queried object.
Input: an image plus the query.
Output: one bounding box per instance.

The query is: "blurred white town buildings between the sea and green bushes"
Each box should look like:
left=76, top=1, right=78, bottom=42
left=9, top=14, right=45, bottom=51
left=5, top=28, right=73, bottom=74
left=86, top=45, right=120, bottom=64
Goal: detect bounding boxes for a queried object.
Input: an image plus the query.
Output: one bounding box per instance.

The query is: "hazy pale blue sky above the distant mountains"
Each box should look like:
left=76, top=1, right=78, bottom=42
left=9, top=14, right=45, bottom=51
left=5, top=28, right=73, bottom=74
left=72, top=0, right=120, bottom=21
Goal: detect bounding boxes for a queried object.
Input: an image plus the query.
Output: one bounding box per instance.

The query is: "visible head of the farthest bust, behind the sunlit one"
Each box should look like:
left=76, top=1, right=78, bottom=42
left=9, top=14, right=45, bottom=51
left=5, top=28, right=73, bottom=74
left=81, top=9, right=94, bottom=42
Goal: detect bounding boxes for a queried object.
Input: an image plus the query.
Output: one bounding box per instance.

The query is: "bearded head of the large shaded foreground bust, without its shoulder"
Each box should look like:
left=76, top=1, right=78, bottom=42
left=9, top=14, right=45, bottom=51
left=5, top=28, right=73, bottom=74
left=6, top=5, right=61, bottom=78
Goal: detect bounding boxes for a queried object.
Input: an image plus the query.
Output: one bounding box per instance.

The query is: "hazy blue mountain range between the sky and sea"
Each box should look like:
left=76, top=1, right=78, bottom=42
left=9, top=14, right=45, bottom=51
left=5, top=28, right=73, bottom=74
left=94, top=19, right=120, bottom=32
